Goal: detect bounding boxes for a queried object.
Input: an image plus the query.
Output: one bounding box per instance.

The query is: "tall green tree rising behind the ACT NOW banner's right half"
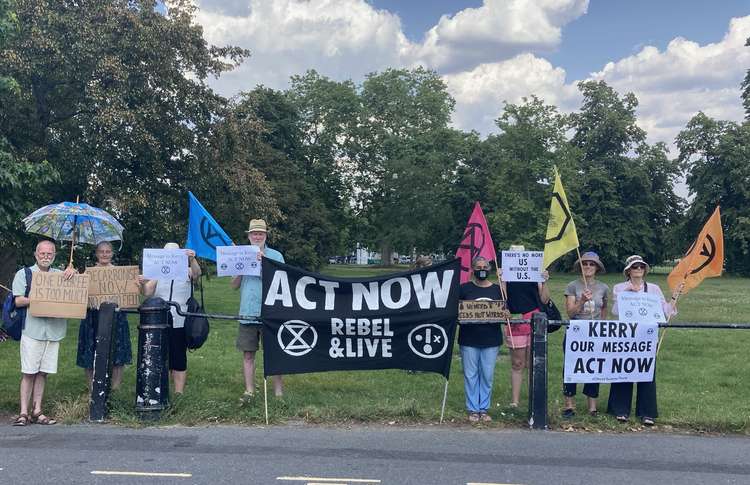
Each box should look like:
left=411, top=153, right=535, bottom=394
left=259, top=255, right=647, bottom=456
left=354, top=68, right=465, bottom=264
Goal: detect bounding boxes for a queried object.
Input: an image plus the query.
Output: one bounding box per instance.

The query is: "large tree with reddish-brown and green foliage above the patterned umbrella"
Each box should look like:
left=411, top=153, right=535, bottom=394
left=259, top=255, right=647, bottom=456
left=0, top=0, right=248, bottom=257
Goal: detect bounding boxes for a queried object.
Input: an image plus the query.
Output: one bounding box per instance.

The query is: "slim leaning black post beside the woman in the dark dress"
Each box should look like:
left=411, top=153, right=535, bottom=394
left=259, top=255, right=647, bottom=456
left=89, top=302, right=117, bottom=423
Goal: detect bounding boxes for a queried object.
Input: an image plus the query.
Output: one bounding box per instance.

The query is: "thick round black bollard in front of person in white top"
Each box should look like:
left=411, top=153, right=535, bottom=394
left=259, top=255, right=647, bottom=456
left=135, top=298, right=169, bottom=420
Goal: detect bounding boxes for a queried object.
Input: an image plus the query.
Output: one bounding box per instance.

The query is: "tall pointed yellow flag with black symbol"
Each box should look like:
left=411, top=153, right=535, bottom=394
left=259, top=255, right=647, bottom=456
left=542, top=167, right=578, bottom=269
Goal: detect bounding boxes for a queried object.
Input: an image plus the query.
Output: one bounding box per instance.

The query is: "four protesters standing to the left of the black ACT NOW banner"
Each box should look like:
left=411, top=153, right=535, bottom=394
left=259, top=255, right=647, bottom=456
left=12, top=219, right=284, bottom=426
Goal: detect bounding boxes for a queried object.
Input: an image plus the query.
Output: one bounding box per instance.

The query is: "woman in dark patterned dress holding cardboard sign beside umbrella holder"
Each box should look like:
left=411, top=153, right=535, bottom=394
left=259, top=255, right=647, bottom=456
left=76, top=241, right=133, bottom=389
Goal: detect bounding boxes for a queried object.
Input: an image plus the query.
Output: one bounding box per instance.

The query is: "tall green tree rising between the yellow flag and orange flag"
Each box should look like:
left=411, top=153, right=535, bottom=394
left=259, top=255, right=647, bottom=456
left=571, top=81, right=681, bottom=267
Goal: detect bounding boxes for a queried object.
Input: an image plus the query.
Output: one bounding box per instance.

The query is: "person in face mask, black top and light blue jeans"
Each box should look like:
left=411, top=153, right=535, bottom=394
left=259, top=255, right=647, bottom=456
left=458, top=257, right=503, bottom=423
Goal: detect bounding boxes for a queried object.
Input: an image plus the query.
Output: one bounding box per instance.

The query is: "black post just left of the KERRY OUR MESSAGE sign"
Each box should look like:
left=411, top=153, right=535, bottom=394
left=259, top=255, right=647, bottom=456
left=529, top=312, right=548, bottom=429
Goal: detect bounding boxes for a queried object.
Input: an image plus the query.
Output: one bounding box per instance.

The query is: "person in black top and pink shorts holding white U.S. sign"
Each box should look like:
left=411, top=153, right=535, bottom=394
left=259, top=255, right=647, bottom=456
left=498, top=245, right=550, bottom=408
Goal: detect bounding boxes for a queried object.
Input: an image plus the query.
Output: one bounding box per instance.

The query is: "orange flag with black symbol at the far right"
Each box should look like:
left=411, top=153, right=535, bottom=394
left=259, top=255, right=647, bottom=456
left=667, top=206, right=724, bottom=294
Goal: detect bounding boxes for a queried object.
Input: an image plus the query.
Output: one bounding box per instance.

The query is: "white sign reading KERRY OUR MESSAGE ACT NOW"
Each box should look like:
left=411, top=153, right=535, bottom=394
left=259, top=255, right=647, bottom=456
left=563, top=320, right=659, bottom=383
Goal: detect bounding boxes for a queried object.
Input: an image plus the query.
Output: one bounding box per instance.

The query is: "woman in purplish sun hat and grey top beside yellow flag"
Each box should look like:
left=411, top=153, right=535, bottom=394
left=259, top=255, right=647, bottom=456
left=563, top=251, right=609, bottom=418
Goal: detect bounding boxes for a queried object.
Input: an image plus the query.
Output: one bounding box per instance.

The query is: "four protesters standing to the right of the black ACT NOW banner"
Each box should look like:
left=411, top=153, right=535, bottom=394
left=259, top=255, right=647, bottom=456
left=458, top=246, right=680, bottom=426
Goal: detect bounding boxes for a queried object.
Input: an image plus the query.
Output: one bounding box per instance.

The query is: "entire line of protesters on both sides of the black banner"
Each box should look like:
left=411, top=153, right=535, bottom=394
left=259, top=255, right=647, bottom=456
left=7, top=219, right=679, bottom=426
